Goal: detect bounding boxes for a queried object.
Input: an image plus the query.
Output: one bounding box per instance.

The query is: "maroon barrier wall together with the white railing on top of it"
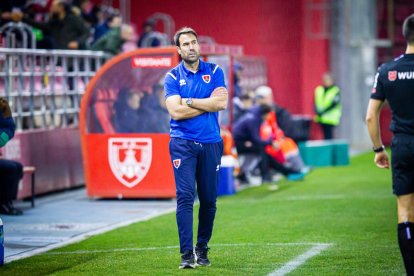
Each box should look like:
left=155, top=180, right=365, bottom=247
left=0, top=48, right=107, bottom=198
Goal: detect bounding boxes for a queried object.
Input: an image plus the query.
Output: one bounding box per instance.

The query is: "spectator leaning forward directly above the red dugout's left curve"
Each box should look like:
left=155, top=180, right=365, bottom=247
left=91, top=24, right=134, bottom=55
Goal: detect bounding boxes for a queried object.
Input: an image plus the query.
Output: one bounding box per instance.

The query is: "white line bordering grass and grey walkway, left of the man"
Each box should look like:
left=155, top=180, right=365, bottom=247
left=5, top=207, right=176, bottom=263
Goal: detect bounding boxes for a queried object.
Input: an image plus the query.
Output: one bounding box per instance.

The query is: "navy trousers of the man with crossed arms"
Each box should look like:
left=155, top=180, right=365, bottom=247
left=170, top=138, right=223, bottom=253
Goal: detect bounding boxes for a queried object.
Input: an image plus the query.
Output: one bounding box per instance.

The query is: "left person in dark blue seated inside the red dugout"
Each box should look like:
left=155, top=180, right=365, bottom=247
left=113, top=88, right=148, bottom=133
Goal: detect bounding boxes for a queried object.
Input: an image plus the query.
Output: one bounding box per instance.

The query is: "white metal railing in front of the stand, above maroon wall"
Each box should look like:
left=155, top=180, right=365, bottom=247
left=0, top=48, right=107, bottom=130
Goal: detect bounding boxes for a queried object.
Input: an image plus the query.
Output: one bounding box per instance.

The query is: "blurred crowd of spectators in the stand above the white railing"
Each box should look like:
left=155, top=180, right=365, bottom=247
left=0, top=0, right=160, bottom=55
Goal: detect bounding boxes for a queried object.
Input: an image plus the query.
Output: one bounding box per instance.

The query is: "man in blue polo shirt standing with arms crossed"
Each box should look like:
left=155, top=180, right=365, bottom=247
left=164, top=27, right=228, bottom=268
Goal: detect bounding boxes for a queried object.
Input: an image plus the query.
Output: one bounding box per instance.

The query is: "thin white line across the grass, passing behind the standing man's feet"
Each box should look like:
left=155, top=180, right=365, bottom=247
left=42, top=242, right=331, bottom=255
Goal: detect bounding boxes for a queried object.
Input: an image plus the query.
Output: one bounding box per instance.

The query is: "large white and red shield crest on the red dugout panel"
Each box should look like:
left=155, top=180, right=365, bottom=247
left=108, top=138, right=152, bottom=188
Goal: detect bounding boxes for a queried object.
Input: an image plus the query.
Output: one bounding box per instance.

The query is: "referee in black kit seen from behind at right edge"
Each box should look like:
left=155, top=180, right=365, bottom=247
left=366, top=14, right=414, bottom=276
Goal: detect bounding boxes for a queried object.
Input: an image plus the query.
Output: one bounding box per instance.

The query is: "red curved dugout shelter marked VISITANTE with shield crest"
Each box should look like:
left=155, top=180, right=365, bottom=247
left=80, top=47, right=178, bottom=198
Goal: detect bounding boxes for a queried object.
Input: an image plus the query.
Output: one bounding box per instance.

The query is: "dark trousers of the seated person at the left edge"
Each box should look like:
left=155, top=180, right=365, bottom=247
left=0, top=159, right=23, bottom=204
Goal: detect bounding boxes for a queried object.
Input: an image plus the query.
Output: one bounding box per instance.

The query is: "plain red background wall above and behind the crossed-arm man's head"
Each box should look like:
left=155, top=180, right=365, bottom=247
left=131, top=0, right=329, bottom=114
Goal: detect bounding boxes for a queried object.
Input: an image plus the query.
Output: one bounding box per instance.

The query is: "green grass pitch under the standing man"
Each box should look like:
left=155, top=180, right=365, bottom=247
left=0, top=154, right=404, bottom=276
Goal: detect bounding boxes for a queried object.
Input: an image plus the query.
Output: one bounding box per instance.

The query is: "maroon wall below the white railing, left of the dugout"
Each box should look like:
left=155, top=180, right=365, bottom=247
left=3, top=127, right=84, bottom=198
